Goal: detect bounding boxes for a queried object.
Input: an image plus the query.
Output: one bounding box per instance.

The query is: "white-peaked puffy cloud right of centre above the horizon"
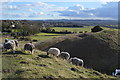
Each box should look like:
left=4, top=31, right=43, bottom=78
left=58, top=4, right=94, bottom=18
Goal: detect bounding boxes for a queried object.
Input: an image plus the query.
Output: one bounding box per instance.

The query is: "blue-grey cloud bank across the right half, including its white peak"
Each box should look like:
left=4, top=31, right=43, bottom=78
left=58, top=2, right=118, bottom=19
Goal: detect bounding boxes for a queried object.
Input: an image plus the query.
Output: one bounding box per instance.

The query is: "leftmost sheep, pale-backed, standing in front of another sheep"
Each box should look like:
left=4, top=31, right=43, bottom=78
left=3, top=39, right=15, bottom=53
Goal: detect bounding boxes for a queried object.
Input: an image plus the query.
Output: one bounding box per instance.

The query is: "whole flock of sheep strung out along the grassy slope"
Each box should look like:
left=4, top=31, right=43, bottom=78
left=3, top=39, right=84, bottom=66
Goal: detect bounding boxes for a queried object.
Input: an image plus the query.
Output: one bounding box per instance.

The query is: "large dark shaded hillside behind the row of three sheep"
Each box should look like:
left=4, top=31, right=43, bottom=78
left=36, top=31, right=120, bottom=74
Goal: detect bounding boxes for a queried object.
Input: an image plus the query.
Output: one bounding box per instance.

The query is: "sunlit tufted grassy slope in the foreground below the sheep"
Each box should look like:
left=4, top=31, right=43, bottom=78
left=2, top=49, right=112, bottom=78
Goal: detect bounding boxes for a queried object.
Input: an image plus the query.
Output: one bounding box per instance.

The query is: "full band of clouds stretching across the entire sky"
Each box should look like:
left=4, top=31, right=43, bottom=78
left=2, top=2, right=118, bottom=19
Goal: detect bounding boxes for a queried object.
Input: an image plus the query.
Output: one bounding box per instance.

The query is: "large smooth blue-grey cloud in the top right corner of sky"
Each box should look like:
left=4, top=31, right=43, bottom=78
left=93, top=2, right=118, bottom=19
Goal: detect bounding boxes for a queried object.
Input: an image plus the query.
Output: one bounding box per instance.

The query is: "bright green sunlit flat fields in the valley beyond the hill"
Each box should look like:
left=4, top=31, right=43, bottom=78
left=25, top=26, right=118, bottom=41
